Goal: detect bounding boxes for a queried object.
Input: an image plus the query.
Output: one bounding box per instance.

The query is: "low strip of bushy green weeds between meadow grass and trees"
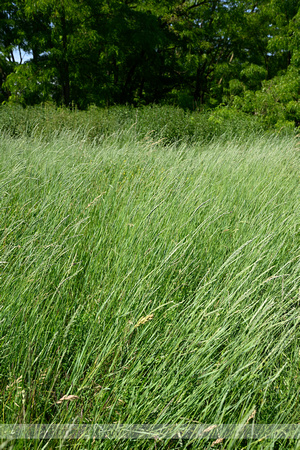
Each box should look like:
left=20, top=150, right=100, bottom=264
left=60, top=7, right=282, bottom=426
left=0, top=104, right=263, bottom=145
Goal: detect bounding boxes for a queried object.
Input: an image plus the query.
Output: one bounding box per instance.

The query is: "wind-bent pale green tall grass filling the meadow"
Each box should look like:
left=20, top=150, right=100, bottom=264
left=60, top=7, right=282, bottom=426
left=0, top=111, right=300, bottom=449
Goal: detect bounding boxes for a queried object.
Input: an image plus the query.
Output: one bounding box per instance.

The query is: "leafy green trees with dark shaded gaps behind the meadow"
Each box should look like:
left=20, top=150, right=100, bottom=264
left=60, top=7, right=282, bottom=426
left=0, top=0, right=300, bottom=120
